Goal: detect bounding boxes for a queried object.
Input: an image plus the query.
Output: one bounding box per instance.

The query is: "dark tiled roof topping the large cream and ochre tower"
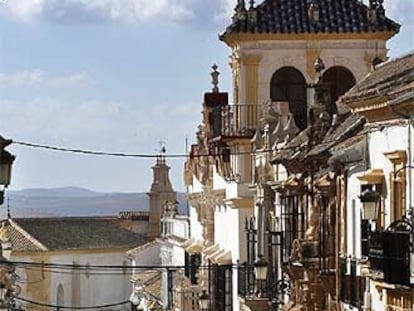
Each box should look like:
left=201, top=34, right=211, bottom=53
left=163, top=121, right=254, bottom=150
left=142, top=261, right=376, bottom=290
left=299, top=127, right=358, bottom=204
left=222, top=0, right=400, bottom=38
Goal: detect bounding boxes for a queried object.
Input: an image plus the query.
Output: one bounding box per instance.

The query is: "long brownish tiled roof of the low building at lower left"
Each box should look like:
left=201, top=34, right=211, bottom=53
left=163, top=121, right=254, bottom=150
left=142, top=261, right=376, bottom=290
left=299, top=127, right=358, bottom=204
left=8, top=217, right=147, bottom=251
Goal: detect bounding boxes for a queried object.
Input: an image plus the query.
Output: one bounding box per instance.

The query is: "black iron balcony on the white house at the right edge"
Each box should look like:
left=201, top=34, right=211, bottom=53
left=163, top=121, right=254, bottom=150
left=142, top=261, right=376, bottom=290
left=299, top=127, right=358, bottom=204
left=368, top=223, right=410, bottom=286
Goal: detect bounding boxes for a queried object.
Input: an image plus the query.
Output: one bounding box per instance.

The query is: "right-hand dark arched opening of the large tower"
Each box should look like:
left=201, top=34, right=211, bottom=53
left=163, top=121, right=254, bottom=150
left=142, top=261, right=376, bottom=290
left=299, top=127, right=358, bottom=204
left=322, top=66, right=356, bottom=103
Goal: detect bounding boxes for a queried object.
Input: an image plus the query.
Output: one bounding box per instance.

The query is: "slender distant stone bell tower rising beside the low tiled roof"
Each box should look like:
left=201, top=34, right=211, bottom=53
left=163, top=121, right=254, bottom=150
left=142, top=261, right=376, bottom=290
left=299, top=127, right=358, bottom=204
left=148, top=145, right=177, bottom=239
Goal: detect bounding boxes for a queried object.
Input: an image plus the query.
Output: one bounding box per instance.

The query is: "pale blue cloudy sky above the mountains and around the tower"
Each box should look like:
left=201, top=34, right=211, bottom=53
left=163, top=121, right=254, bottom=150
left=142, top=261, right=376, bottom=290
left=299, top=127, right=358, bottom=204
left=0, top=0, right=414, bottom=192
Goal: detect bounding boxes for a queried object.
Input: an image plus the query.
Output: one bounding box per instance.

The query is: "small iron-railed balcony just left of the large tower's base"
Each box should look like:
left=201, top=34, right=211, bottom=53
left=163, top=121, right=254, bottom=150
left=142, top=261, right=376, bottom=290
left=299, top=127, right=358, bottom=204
left=210, top=105, right=258, bottom=141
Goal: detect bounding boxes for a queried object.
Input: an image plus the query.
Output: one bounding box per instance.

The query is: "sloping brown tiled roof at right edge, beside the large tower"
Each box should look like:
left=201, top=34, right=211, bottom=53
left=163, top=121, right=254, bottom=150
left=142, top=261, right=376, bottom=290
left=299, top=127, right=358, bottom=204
left=341, top=53, right=414, bottom=104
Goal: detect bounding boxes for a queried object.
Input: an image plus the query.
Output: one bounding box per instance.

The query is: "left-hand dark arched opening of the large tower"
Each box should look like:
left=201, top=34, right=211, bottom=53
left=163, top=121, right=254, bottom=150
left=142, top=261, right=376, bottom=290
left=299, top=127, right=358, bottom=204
left=270, top=67, right=307, bottom=130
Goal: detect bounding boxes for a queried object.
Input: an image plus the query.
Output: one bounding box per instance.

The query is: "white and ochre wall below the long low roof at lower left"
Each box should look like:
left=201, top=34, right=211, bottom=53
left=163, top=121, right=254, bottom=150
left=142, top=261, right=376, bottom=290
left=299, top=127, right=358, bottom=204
left=11, top=250, right=130, bottom=310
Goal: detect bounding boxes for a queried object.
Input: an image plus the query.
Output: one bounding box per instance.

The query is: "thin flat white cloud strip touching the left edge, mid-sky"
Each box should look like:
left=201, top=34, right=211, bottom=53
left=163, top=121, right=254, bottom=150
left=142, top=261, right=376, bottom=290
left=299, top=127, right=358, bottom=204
left=0, top=69, right=96, bottom=86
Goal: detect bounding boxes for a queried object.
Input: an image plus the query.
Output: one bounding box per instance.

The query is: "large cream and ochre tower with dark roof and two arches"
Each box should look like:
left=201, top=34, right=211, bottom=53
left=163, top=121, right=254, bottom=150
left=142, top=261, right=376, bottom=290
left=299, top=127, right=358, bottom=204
left=220, top=0, right=400, bottom=130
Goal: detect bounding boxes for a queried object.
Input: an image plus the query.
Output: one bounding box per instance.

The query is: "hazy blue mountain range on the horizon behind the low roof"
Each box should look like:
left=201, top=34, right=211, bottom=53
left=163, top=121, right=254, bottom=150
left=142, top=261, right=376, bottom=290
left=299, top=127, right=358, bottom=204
left=0, top=187, right=187, bottom=218
